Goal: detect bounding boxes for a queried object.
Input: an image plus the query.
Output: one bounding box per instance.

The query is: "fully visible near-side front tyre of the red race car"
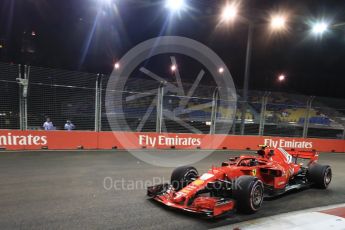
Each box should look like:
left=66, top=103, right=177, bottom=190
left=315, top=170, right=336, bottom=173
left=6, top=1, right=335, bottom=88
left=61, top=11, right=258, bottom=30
left=233, top=176, right=264, bottom=214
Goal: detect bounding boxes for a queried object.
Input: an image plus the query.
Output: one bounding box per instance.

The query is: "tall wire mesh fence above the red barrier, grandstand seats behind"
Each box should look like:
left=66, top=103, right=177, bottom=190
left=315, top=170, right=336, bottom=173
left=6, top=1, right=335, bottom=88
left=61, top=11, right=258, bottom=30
left=0, top=63, right=345, bottom=139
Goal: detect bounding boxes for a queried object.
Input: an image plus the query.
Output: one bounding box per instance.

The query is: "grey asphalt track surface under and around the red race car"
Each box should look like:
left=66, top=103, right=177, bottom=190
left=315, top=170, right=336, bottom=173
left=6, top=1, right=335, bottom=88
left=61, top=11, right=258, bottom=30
left=0, top=151, right=345, bottom=229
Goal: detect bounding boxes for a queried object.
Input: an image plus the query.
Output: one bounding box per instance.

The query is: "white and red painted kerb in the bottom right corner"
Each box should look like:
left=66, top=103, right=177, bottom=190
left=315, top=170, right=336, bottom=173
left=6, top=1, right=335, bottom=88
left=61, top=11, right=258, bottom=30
left=215, top=204, right=345, bottom=230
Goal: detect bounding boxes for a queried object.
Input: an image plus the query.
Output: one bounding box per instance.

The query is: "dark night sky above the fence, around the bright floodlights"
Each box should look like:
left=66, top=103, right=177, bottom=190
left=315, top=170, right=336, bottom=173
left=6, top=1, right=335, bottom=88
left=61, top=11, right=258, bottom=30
left=0, top=0, right=345, bottom=98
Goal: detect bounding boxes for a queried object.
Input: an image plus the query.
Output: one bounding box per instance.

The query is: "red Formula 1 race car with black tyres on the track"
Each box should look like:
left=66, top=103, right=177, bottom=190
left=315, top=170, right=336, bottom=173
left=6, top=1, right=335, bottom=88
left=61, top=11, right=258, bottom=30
left=147, top=146, right=332, bottom=217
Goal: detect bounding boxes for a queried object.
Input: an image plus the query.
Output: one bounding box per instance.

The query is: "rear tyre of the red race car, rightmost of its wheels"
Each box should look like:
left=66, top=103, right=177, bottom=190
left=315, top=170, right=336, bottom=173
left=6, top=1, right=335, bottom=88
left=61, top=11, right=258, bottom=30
left=308, top=164, right=332, bottom=189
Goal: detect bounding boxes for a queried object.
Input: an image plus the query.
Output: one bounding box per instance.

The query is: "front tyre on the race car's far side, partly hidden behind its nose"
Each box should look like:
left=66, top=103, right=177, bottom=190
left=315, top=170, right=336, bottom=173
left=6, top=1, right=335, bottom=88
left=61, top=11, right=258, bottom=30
left=171, top=166, right=198, bottom=191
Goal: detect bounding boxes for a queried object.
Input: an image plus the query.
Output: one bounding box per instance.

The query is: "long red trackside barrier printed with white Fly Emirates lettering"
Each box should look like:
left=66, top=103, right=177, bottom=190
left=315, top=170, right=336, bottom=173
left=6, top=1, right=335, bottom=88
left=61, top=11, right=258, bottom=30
left=0, top=130, right=345, bottom=152
